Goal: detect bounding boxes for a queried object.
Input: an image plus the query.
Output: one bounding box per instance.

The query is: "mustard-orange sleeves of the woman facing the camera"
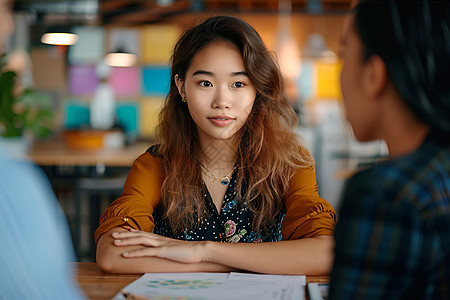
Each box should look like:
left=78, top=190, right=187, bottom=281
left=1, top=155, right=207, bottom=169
left=95, top=152, right=336, bottom=243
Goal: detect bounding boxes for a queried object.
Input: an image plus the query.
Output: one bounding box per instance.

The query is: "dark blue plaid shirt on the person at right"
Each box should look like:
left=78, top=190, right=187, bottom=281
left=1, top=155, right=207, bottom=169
left=329, top=136, right=450, bottom=300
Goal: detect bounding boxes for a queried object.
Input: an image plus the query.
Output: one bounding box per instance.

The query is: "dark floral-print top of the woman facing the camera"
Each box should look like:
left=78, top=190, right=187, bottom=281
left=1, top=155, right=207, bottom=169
left=153, top=174, right=283, bottom=243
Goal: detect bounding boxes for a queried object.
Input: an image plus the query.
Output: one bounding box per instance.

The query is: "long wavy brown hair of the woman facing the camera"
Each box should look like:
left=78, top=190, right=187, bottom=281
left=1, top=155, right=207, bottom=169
left=157, top=16, right=314, bottom=231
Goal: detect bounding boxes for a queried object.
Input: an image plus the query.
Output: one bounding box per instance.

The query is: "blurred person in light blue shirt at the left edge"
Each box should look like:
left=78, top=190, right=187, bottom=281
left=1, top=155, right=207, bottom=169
left=0, top=0, right=82, bottom=300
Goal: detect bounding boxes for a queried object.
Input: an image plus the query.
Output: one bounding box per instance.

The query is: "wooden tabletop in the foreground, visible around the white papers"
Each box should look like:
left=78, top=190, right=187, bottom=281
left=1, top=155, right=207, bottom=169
left=70, top=262, right=329, bottom=300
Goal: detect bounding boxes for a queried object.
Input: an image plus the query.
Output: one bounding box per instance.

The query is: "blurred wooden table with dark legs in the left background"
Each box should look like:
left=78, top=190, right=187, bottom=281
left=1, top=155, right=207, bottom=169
left=29, top=135, right=153, bottom=260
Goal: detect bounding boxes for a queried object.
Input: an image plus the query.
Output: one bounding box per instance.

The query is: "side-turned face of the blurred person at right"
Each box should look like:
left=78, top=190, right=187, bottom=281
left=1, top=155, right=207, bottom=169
left=340, top=16, right=379, bottom=142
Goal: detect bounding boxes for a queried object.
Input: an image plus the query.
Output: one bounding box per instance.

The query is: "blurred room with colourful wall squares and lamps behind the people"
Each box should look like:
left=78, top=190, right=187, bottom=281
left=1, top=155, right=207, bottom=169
left=0, top=0, right=387, bottom=261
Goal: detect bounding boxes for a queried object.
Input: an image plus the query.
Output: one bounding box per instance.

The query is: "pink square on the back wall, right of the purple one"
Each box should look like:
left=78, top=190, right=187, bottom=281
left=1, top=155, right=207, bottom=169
left=109, top=67, right=140, bottom=96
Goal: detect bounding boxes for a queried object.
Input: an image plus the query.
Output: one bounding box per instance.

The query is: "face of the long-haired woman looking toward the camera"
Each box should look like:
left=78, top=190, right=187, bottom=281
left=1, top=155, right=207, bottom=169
left=175, top=42, right=256, bottom=145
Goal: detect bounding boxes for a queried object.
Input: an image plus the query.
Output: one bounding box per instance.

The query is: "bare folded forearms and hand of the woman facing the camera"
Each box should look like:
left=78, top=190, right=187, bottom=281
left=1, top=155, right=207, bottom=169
left=97, top=228, right=334, bottom=275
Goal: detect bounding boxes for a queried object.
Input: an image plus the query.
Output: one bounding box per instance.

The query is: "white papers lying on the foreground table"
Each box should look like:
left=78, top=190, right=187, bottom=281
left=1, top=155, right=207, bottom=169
left=113, top=272, right=306, bottom=300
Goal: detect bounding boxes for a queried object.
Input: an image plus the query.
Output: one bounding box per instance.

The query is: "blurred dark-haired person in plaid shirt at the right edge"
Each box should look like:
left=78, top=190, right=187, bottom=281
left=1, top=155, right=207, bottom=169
left=329, top=0, right=450, bottom=299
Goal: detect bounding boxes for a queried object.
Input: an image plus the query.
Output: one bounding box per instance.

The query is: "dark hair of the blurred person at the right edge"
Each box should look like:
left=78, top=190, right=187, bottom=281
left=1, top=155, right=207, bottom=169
left=355, top=0, right=450, bottom=138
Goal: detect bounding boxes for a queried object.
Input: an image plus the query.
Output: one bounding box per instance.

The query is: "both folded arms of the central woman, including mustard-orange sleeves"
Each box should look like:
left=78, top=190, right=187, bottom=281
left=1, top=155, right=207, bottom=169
left=96, top=153, right=335, bottom=275
